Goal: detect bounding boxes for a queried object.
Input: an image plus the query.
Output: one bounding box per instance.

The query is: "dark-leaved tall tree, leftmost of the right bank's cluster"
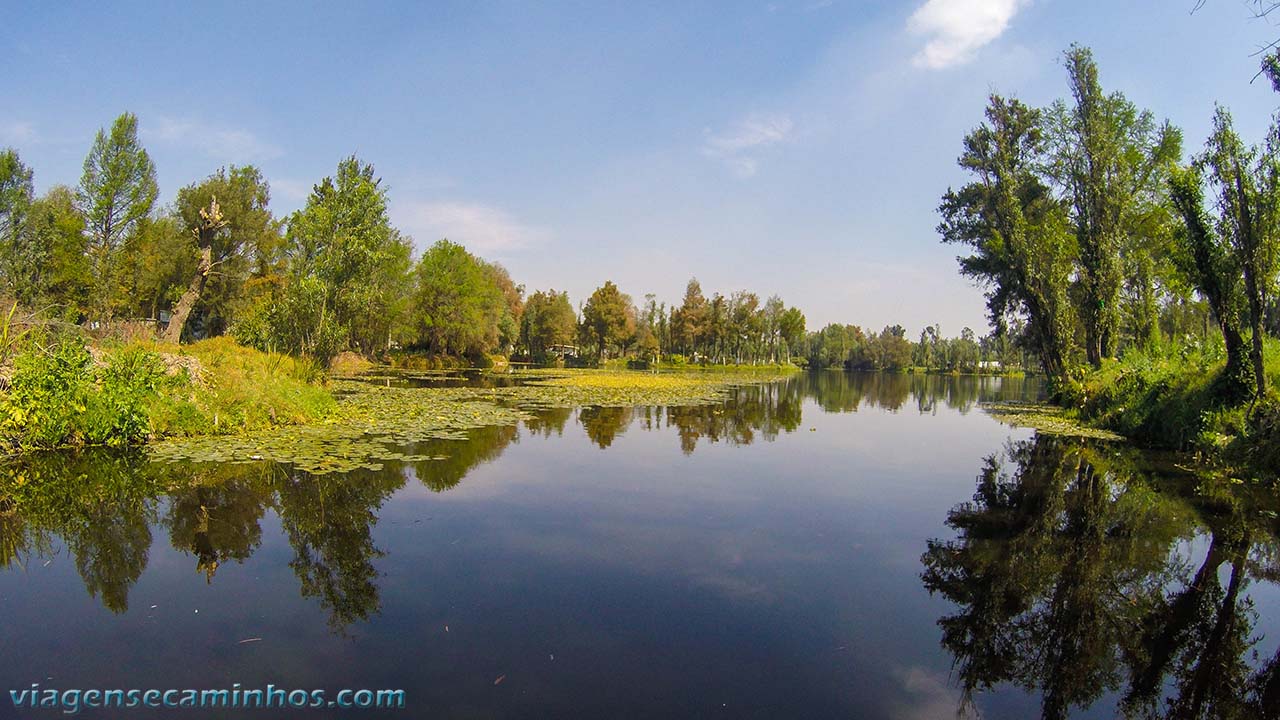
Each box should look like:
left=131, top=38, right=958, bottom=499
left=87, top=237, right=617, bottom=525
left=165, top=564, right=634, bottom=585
left=938, top=95, right=1075, bottom=382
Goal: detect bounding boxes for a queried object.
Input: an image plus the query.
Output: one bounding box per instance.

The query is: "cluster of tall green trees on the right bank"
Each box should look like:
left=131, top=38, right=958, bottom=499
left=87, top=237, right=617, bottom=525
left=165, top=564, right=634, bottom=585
left=938, top=46, right=1280, bottom=402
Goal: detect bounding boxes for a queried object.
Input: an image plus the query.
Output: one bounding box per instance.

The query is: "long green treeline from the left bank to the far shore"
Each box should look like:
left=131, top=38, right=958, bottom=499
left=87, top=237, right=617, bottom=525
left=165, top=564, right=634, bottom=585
left=0, top=113, right=1009, bottom=370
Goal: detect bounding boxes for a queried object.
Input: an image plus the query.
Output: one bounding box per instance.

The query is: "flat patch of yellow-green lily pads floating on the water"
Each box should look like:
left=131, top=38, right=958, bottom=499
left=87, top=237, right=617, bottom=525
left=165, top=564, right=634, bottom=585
left=150, top=370, right=777, bottom=475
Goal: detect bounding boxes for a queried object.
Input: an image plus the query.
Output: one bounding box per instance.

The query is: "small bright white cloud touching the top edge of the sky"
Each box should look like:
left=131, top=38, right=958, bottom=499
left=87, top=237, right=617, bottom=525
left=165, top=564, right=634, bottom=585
left=906, top=0, right=1029, bottom=69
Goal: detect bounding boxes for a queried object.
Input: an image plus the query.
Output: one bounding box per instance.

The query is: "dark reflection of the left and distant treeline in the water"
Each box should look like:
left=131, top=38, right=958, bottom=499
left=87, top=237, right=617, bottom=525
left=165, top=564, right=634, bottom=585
left=0, top=373, right=1034, bottom=622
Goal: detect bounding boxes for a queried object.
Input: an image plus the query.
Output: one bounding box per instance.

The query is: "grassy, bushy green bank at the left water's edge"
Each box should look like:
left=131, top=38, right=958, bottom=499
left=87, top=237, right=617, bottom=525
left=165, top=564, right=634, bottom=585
left=0, top=333, right=334, bottom=452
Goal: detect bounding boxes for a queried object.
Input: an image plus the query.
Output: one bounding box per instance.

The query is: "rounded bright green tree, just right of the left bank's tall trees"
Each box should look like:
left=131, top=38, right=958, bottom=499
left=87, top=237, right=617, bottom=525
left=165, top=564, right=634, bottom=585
left=413, top=240, right=508, bottom=355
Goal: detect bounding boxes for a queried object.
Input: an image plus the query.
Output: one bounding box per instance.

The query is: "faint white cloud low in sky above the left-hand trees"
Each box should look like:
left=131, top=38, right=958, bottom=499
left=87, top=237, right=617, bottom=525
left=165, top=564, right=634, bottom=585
left=392, top=201, right=550, bottom=254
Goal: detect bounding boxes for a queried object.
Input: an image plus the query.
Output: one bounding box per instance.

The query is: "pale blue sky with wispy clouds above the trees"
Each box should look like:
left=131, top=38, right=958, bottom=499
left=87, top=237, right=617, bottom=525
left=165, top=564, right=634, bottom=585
left=0, top=0, right=1280, bottom=336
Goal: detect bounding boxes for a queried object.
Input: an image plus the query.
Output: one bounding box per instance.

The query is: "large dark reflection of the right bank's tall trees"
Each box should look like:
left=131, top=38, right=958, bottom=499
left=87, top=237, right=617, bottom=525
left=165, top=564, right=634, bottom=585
left=922, top=437, right=1280, bottom=719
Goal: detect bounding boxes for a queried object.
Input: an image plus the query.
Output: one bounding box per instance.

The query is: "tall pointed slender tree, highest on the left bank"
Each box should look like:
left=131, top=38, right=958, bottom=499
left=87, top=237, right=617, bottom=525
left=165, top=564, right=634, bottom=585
left=79, top=113, right=159, bottom=320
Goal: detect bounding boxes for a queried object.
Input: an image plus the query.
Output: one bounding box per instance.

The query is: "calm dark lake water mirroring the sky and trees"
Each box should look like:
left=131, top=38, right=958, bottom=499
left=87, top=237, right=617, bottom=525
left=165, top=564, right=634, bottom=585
left=0, top=373, right=1280, bottom=719
